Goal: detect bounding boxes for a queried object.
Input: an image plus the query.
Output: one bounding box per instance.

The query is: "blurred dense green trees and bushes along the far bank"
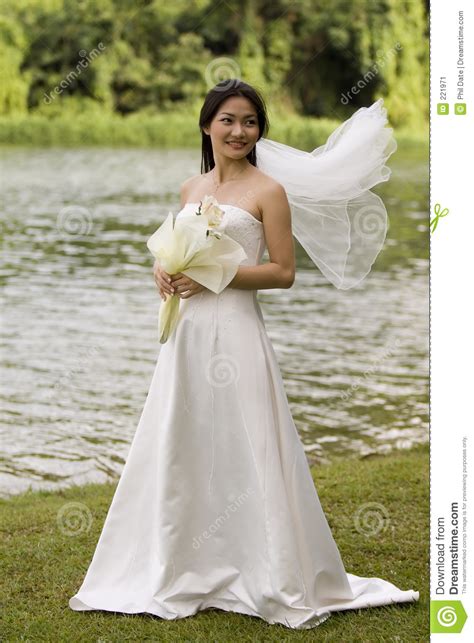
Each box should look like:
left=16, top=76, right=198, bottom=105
left=0, top=0, right=429, bottom=127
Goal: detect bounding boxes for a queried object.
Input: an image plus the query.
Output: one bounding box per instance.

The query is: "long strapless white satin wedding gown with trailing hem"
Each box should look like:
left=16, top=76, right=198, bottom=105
left=69, top=203, right=419, bottom=629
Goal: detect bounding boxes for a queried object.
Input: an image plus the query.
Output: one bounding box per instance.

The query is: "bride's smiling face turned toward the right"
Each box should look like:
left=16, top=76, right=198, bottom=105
left=203, top=96, right=259, bottom=159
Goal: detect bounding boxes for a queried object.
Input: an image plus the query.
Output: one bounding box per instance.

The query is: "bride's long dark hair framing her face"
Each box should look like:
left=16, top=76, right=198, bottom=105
left=199, top=78, right=270, bottom=174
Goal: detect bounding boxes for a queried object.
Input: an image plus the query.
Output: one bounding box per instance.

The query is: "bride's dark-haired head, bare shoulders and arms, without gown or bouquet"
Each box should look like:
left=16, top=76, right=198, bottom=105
left=155, top=83, right=295, bottom=299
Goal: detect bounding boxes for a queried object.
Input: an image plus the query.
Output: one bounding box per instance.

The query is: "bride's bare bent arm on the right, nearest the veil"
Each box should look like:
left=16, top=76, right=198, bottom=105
left=228, top=182, right=295, bottom=290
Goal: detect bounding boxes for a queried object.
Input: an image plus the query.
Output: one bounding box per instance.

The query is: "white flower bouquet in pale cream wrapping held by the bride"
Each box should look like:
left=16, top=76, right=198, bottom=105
left=146, top=195, right=247, bottom=344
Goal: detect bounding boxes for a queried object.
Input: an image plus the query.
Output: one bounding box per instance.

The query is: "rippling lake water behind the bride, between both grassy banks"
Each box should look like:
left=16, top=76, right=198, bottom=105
left=0, top=147, right=429, bottom=496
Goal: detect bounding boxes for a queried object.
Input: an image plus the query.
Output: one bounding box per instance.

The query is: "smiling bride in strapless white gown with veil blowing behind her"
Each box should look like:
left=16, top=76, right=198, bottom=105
left=69, top=80, right=419, bottom=629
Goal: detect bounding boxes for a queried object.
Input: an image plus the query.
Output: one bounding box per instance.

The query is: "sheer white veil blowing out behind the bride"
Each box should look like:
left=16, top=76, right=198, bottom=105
left=256, top=98, right=397, bottom=290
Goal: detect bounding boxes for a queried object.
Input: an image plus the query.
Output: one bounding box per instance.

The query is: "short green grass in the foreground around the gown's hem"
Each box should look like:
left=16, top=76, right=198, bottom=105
left=0, top=445, right=429, bottom=643
